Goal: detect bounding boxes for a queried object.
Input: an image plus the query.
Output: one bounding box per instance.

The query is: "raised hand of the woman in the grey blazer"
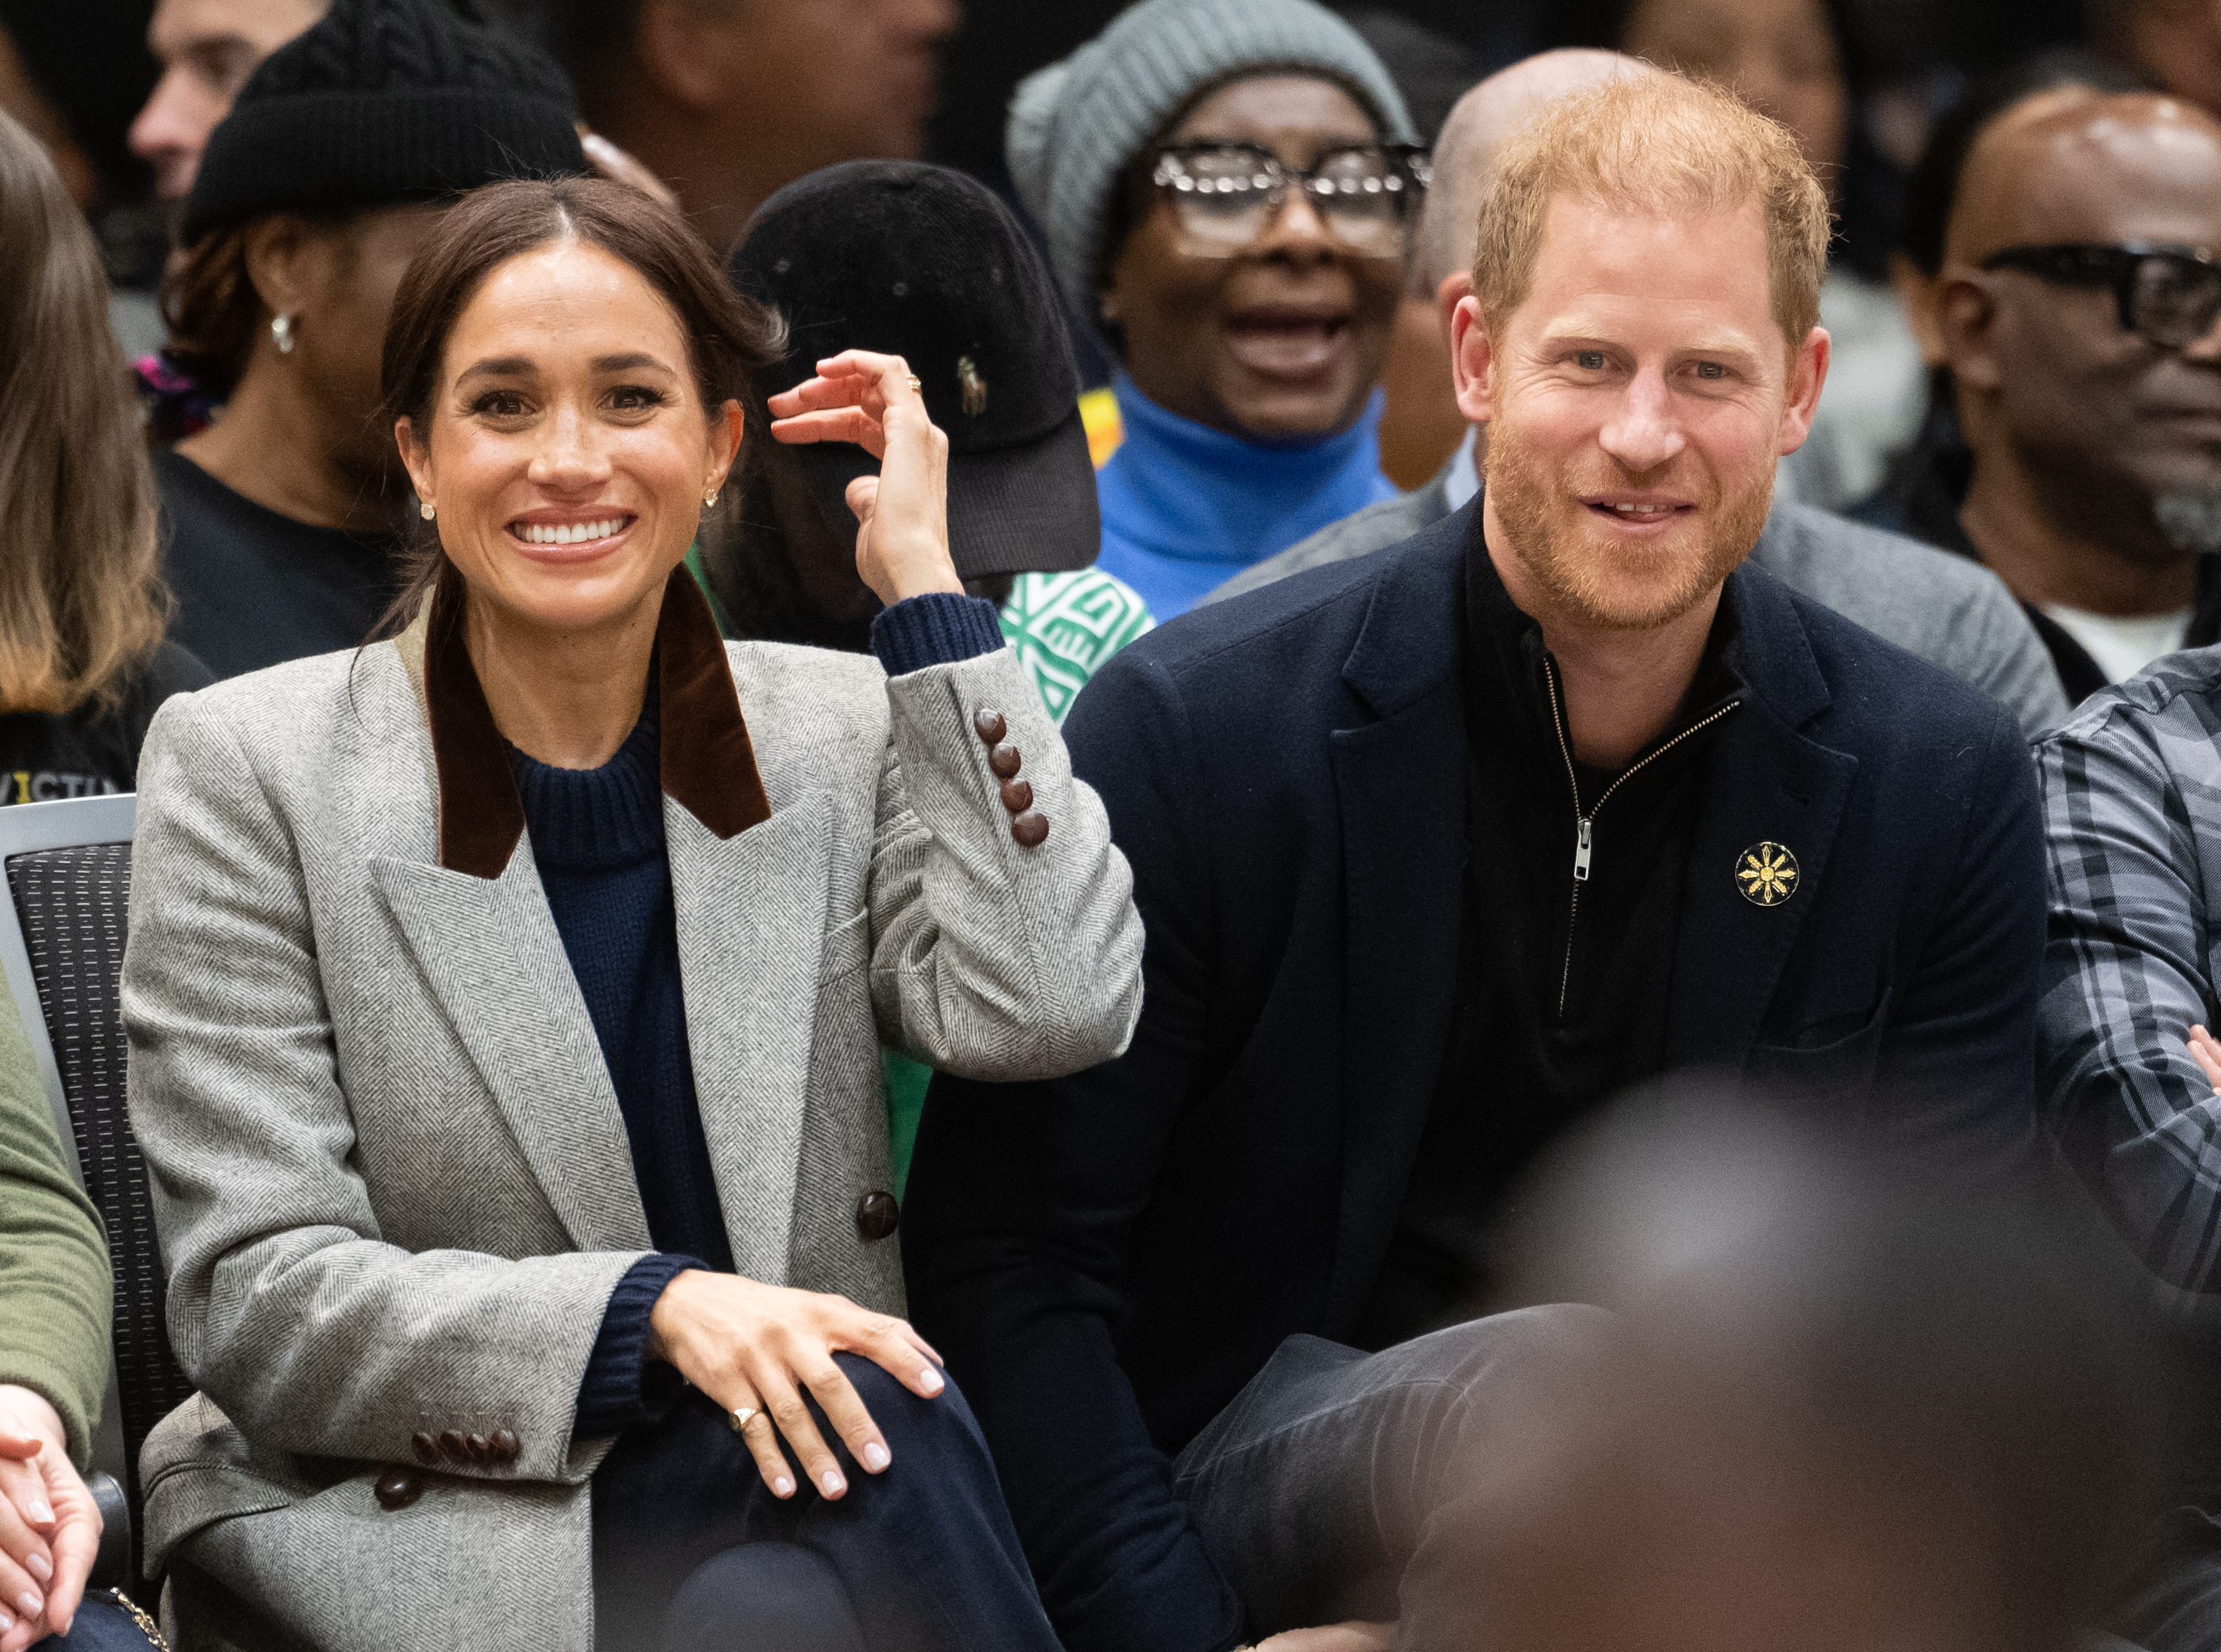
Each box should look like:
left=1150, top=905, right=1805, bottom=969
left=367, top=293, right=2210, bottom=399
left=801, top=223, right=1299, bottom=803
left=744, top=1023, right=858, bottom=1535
left=771, top=351, right=964, bottom=606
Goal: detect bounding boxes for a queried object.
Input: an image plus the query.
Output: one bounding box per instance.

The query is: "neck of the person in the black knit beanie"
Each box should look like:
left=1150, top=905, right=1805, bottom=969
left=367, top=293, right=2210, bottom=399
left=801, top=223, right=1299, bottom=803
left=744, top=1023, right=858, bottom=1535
left=178, top=360, right=400, bottom=533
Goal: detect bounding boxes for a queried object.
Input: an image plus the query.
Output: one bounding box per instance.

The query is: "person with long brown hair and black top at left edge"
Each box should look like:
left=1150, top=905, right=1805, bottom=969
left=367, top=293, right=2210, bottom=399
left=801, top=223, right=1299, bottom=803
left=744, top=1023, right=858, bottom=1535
left=0, top=113, right=209, bottom=804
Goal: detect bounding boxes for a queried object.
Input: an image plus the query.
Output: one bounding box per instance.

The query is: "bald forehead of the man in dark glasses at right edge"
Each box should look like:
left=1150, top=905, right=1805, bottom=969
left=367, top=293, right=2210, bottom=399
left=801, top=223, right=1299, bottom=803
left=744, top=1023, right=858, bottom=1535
left=1948, top=93, right=2221, bottom=262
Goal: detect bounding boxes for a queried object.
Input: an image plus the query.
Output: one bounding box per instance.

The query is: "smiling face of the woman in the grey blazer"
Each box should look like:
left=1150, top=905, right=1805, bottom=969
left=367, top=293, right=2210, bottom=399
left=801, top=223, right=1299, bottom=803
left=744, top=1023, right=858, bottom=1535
left=400, top=242, right=740, bottom=633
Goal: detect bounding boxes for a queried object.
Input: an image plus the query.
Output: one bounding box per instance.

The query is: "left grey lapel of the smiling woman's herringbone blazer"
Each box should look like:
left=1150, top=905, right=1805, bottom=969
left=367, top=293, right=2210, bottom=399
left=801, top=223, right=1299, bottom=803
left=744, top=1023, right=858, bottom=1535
left=371, top=839, right=649, bottom=1250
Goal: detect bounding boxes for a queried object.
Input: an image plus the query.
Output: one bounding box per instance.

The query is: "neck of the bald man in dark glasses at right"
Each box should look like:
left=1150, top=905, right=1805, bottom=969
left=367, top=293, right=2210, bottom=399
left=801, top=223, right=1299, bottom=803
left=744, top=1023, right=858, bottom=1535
left=1959, top=449, right=2199, bottom=617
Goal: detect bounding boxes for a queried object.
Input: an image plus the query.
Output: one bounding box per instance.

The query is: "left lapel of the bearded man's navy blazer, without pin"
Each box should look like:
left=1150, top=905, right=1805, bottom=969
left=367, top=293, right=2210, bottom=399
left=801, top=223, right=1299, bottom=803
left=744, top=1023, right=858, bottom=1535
left=1328, top=513, right=1466, bottom=1328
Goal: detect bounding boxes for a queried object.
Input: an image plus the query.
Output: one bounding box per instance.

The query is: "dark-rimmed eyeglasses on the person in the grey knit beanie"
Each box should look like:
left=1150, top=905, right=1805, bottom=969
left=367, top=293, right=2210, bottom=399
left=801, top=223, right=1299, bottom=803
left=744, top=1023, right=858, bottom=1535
left=1150, top=144, right=1430, bottom=258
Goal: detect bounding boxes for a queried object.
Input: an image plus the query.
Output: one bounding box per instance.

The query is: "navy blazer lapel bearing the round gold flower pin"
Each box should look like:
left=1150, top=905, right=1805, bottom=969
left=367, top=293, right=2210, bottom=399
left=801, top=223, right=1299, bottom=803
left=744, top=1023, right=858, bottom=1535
left=1666, top=571, right=1859, bottom=1070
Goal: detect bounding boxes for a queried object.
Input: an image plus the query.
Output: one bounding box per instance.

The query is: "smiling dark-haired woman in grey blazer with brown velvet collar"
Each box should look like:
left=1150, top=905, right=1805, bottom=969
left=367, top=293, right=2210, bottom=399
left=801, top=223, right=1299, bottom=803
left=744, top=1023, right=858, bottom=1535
left=122, top=171, right=1142, bottom=1652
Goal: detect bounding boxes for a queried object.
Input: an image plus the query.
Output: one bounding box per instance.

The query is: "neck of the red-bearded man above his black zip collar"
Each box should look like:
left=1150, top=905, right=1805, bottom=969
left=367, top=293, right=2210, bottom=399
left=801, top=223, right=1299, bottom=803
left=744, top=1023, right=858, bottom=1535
left=1481, top=500, right=1719, bottom=768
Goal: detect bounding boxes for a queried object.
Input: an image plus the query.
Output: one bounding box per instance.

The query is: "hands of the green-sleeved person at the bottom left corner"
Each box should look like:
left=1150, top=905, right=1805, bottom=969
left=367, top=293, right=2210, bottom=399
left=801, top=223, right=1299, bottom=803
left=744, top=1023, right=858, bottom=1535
left=0, top=1383, right=100, bottom=1652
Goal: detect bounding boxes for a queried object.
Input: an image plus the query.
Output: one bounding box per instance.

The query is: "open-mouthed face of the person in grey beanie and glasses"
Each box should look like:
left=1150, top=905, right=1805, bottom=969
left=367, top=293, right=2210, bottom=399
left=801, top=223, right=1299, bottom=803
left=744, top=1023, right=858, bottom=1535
left=1102, top=75, right=1404, bottom=440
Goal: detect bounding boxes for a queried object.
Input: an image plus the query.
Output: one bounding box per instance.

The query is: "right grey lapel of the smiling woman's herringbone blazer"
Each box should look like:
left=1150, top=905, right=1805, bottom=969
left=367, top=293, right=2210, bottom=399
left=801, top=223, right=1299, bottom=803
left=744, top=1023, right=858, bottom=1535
left=664, top=793, right=831, bottom=1283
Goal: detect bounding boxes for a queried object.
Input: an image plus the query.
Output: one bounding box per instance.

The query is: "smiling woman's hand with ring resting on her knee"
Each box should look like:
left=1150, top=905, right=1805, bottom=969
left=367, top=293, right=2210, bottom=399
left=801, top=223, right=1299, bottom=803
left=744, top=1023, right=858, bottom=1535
left=649, top=1268, right=946, bottom=1497
